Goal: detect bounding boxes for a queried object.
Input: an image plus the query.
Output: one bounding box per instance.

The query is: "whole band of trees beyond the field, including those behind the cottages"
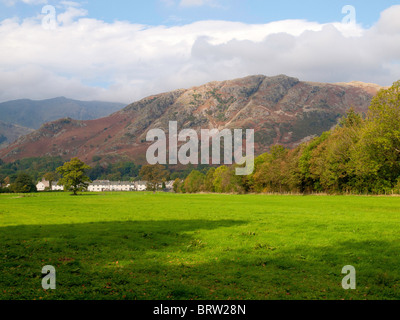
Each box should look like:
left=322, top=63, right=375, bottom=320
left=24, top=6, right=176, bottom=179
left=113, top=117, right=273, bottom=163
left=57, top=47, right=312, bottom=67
left=0, top=81, right=400, bottom=194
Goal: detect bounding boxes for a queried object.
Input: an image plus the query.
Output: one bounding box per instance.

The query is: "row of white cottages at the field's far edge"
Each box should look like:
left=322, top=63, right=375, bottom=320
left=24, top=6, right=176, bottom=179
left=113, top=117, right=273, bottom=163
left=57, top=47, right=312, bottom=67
left=36, top=179, right=174, bottom=192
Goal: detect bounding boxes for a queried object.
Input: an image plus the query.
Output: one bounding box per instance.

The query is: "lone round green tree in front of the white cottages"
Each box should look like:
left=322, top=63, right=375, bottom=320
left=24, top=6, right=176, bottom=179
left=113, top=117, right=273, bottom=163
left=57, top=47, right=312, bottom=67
left=57, top=158, right=92, bottom=196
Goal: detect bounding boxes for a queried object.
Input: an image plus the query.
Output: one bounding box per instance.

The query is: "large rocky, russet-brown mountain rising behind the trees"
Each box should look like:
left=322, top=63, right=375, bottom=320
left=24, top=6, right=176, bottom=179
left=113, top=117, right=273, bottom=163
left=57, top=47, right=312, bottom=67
left=0, top=75, right=380, bottom=164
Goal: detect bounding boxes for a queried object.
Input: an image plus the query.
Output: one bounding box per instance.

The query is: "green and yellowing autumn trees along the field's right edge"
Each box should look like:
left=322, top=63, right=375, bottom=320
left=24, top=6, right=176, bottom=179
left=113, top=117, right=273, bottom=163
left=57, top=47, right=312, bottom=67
left=174, top=81, right=400, bottom=194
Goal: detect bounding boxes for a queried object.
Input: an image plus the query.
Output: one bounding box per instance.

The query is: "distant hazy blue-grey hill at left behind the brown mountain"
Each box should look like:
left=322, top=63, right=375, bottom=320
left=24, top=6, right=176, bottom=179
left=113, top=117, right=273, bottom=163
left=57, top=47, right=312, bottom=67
left=0, top=97, right=125, bottom=129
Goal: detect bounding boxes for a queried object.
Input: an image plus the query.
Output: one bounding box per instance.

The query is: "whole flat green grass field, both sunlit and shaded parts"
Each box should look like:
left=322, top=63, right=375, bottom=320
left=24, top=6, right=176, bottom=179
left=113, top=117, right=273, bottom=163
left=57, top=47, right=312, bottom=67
left=0, top=193, right=400, bottom=300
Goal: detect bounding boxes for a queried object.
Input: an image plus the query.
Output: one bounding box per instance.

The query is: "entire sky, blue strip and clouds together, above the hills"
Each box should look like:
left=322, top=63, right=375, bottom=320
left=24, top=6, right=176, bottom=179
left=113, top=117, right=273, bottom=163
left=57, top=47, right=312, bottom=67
left=0, top=0, right=400, bottom=104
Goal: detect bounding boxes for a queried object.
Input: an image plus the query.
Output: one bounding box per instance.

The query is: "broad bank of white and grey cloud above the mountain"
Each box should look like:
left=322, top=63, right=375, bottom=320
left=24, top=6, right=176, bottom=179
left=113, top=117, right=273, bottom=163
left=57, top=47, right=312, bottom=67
left=0, top=6, right=400, bottom=103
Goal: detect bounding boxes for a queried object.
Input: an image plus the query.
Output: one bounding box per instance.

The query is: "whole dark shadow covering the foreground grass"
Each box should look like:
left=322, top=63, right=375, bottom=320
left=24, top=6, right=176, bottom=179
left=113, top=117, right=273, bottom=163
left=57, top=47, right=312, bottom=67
left=0, top=220, right=400, bottom=300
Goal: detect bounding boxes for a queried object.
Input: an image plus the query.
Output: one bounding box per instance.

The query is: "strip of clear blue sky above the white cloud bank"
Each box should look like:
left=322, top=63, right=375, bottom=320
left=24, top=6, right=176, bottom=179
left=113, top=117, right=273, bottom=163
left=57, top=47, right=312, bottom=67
left=0, top=0, right=398, bottom=27
